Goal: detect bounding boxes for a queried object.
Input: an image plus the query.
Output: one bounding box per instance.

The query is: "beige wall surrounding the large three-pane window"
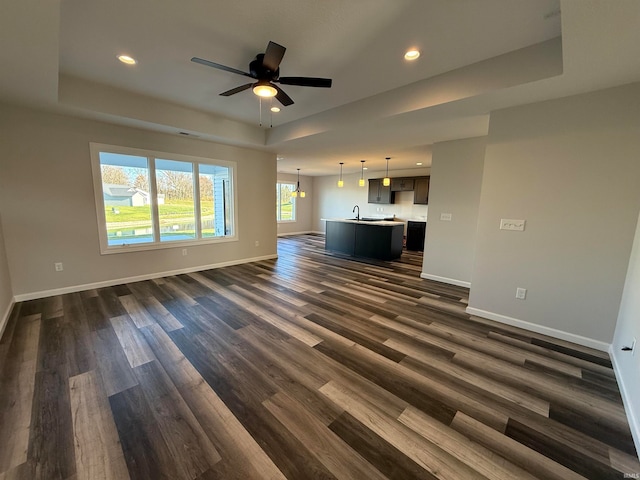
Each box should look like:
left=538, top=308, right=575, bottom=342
left=0, top=105, right=276, bottom=299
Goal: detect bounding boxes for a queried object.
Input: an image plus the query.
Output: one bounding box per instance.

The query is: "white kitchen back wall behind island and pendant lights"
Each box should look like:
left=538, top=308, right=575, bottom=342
left=313, top=168, right=430, bottom=233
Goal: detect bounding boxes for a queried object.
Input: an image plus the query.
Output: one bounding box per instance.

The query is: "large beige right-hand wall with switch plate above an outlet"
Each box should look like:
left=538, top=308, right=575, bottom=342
left=468, top=83, right=640, bottom=350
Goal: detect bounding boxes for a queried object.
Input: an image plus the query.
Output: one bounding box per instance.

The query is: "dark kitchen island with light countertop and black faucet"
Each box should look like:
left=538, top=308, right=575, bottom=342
left=324, top=219, right=404, bottom=260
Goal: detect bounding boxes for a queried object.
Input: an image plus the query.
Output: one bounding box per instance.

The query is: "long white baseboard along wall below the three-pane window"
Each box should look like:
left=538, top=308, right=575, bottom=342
left=15, top=254, right=278, bottom=302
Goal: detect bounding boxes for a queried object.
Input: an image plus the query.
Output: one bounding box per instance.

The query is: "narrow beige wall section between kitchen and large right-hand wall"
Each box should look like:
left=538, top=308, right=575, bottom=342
left=420, top=137, right=486, bottom=287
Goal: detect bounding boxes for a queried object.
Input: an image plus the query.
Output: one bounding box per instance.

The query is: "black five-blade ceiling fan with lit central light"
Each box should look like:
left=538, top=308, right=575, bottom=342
left=191, top=42, right=331, bottom=107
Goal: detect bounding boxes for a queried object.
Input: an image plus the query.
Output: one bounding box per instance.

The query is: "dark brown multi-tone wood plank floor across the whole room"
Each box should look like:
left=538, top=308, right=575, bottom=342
left=0, top=235, right=640, bottom=480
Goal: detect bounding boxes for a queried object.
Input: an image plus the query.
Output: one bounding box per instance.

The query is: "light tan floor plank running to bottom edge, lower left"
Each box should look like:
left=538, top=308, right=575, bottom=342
left=69, top=370, right=129, bottom=480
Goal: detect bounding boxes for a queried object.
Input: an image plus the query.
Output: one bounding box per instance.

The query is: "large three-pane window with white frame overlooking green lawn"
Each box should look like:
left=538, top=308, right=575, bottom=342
left=91, top=143, right=236, bottom=253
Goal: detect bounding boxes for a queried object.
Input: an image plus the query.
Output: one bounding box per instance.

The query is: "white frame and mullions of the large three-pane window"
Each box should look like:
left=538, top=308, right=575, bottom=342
left=89, top=142, right=239, bottom=255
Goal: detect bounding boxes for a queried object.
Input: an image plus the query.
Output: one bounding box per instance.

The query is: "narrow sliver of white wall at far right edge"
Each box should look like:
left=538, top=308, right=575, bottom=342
left=609, top=210, right=640, bottom=452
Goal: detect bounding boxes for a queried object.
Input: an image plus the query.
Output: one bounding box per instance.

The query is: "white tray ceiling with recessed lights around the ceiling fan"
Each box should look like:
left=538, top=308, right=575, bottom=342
left=0, top=0, right=640, bottom=175
